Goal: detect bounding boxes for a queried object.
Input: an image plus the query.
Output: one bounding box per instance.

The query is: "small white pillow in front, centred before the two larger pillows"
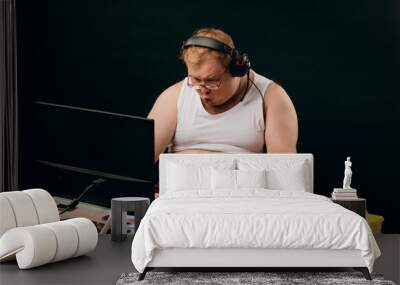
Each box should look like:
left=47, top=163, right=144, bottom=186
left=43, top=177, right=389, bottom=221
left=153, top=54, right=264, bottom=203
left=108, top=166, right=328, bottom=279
left=211, top=168, right=267, bottom=190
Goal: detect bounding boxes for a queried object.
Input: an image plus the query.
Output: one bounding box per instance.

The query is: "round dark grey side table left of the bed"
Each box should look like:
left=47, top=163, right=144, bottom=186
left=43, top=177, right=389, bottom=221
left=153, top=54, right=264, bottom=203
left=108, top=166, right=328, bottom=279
left=111, top=197, right=150, bottom=241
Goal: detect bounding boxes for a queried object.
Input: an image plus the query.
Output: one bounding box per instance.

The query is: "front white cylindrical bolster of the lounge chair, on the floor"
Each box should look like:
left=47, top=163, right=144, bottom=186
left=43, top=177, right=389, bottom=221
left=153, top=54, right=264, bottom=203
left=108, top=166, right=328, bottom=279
left=0, top=218, right=97, bottom=269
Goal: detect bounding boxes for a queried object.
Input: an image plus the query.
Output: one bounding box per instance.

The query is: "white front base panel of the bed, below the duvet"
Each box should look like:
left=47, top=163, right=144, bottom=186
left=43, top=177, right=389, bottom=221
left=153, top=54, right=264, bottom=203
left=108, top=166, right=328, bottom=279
left=147, top=248, right=367, bottom=267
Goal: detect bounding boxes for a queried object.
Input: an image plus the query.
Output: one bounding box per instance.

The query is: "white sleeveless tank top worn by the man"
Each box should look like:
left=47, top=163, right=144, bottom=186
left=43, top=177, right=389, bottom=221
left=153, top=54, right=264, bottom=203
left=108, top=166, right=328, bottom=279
left=171, top=71, right=271, bottom=153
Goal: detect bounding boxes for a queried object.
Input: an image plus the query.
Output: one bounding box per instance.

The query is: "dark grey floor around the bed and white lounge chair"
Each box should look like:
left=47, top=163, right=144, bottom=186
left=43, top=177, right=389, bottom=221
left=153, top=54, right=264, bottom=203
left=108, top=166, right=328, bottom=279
left=0, top=234, right=400, bottom=285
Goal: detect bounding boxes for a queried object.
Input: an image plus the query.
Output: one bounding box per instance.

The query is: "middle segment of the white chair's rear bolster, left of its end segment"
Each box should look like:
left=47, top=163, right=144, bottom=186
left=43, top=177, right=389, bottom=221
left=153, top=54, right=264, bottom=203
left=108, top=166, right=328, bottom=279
left=1, top=191, right=39, bottom=227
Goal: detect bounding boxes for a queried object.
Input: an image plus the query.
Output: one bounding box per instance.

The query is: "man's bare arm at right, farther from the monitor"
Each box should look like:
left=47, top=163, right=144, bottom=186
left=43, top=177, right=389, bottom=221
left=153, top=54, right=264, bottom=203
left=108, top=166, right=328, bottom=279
left=264, top=82, right=298, bottom=153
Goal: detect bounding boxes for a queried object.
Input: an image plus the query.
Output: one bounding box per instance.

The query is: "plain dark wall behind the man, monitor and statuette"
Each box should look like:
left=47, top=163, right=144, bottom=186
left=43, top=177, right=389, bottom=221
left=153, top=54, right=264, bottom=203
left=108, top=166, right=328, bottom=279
left=17, top=0, right=400, bottom=233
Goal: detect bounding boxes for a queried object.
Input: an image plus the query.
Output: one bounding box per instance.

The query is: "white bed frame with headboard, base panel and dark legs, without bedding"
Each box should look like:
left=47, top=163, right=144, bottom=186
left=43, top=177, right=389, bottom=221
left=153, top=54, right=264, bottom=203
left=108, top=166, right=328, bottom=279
left=139, top=154, right=371, bottom=280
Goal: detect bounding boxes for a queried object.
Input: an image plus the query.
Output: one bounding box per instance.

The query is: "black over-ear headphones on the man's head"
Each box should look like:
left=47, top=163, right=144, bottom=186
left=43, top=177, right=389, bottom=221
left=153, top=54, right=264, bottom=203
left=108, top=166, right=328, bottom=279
left=181, top=36, right=251, bottom=77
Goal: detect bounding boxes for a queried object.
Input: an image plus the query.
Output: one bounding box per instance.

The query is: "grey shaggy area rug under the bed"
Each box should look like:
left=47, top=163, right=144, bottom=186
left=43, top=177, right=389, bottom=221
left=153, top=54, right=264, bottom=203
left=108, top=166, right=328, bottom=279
left=117, top=271, right=395, bottom=285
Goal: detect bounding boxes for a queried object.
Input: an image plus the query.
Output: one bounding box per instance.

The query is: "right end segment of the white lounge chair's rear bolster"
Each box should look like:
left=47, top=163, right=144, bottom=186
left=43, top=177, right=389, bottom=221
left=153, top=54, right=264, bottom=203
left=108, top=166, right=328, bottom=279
left=22, top=188, right=60, bottom=224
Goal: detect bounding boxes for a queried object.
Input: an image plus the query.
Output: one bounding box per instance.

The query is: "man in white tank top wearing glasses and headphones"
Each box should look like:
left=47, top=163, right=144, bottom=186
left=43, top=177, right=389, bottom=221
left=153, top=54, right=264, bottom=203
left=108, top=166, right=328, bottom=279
left=148, top=28, right=298, bottom=160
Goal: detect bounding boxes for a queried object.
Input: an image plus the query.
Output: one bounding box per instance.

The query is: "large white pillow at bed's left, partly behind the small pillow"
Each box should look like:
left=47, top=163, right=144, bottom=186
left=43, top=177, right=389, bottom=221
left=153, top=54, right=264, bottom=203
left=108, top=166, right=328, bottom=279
left=167, top=160, right=235, bottom=191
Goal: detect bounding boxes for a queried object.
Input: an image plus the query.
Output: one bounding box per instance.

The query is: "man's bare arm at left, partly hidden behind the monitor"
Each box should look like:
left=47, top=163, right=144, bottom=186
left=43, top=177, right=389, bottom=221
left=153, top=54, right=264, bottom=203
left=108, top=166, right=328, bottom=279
left=147, top=82, right=182, bottom=161
